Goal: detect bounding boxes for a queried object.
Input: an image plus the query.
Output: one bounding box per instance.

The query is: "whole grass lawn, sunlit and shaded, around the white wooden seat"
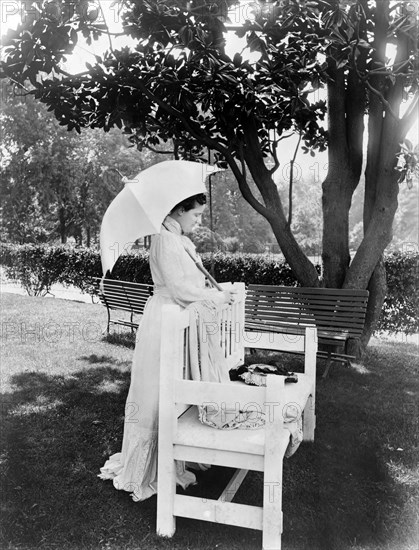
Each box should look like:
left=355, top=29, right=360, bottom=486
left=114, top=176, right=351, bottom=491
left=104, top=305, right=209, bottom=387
left=0, top=294, right=419, bottom=550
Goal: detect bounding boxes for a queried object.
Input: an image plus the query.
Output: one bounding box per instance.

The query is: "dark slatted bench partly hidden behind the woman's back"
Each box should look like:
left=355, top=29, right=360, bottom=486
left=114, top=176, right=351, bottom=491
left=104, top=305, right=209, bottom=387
left=92, top=277, right=153, bottom=332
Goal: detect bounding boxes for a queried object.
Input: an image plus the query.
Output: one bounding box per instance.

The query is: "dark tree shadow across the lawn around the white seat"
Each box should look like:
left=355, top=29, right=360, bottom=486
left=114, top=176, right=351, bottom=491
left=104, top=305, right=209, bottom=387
left=1, top=349, right=417, bottom=550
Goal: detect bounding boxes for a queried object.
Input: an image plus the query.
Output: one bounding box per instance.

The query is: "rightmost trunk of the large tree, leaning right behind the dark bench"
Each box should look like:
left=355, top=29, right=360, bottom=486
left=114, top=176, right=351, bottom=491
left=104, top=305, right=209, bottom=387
left=345, top=0, right=413, bottom=353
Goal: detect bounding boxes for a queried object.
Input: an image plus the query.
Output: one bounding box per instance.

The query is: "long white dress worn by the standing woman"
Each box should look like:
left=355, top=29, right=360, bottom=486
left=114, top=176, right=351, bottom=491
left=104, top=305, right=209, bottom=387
left=99, top=216, right=224, bottom=501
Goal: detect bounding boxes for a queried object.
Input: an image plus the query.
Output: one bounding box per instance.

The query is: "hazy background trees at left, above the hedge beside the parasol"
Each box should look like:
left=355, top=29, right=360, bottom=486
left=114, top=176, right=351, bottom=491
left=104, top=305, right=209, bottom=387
left=0, top=81, right=156, bottom=246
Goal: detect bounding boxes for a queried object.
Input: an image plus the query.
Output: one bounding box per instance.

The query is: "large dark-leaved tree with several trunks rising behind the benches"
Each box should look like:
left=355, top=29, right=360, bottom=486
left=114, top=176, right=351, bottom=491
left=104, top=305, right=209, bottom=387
left=2, top=0, right=419, bottom=354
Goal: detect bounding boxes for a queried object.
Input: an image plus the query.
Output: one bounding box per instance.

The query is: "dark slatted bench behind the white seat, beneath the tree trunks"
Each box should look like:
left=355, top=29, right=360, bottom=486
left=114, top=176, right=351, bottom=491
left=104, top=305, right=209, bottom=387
left=245, top=285, right=368, bottom=377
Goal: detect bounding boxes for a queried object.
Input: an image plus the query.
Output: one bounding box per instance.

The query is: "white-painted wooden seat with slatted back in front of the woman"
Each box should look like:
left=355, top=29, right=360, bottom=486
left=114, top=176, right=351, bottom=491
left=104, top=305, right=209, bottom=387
left=157, top=288, right=317, bottom=550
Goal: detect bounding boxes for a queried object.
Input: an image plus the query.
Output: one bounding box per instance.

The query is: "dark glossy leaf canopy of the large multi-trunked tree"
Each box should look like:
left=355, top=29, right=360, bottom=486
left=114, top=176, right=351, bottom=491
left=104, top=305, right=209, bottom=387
left=0, top=0, right=418, bottom=165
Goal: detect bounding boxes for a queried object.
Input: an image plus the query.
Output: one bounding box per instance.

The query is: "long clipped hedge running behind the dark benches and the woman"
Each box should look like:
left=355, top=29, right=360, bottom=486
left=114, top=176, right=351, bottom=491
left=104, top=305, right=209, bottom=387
left=0, top=244, right=419, bottom=334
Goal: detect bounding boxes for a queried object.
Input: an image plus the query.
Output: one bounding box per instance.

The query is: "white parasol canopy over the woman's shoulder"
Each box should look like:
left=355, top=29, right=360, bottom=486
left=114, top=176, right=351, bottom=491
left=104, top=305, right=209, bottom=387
left=100, top=160, right=220, bottom=275
